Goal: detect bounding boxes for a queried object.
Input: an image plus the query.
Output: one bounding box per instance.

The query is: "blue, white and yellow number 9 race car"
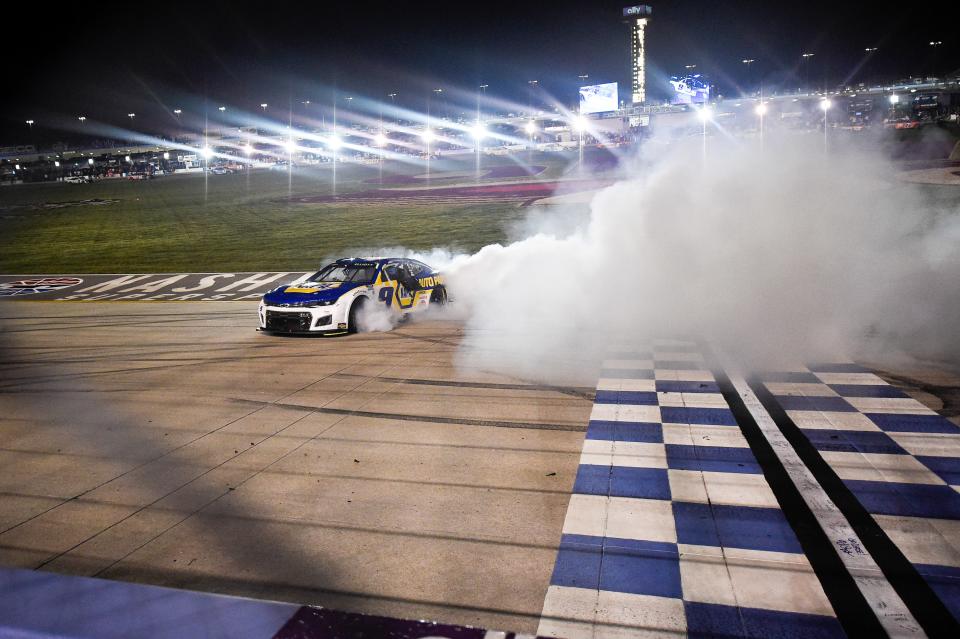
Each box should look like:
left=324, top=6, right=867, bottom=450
left=258, top=257, right=447, bottom=335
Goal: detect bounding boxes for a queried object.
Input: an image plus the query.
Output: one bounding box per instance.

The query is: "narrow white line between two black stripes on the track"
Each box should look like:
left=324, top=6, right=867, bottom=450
left=721, top=356, right=926, bottom=637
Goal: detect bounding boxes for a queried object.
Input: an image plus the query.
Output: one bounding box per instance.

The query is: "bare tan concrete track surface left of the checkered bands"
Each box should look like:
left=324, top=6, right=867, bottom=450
left=0, top=300, right=593, bottom=632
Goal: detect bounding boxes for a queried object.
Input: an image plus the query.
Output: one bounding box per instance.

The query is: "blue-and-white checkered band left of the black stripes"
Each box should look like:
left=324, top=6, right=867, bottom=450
left=539, top=341, right=844, bottom=639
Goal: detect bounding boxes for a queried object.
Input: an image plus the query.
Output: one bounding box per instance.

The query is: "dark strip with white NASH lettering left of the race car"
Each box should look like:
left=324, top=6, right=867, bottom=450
left=0, top=272, right=310, bottom=302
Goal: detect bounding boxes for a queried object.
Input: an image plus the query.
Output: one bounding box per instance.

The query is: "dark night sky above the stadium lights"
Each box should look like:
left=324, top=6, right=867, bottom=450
left=0, top=0, right=960, bottom=145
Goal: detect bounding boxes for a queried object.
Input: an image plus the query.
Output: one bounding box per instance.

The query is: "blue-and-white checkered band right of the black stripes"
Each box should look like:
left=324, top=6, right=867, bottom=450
left=760, top=362, right=960, bottom=621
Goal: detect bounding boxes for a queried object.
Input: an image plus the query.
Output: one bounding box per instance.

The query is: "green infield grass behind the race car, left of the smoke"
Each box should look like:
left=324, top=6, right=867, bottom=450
left=0, top=158, right=561, bottom=274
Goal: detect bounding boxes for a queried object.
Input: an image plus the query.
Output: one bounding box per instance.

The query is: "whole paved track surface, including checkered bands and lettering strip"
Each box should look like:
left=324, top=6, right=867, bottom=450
left=0, top=298, right=960, bottom=638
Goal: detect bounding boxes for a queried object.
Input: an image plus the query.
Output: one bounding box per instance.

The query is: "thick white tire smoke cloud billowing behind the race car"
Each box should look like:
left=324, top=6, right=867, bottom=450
left=442, top=136, right=960, bottom=381
